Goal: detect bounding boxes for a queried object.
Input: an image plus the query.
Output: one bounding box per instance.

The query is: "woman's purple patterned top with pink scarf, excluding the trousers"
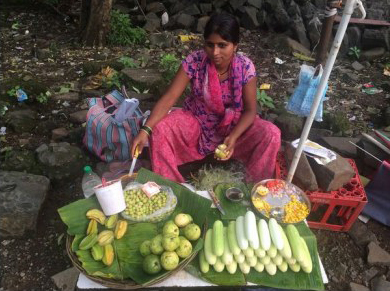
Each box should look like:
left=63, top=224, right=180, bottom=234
left=182, top=50, right=256, bottom=155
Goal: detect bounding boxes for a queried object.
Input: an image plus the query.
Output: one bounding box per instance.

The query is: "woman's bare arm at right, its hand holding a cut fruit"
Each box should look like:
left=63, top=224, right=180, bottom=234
left=224, top=77, right=257, bottom=160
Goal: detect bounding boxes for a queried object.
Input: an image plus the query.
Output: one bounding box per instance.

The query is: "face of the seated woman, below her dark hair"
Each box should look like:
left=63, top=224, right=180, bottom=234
left=205, top=33, right=237, bottom=67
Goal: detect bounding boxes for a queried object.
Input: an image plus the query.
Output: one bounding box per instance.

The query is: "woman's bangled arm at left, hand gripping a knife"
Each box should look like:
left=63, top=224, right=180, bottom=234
left=131, top=65, right=190, bottom=156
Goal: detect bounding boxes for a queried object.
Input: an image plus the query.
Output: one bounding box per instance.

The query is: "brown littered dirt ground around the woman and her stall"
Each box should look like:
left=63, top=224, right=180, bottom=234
left=0, top=2, right=390, bottom=291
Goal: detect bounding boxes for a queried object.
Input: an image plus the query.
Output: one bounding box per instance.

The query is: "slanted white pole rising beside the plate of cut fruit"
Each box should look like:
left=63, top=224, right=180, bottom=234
left=287, top=0, right=365, bottom=183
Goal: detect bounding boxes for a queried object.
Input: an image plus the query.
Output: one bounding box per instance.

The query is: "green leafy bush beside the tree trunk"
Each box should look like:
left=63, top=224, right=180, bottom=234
left=108, top=10, right=146, bottom=45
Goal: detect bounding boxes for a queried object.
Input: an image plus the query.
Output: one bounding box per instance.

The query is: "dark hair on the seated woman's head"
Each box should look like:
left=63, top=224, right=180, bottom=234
left=203, top=13, right=240, bottom=44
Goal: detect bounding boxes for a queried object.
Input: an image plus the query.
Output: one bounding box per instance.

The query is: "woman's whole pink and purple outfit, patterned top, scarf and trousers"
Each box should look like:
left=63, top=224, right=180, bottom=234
left=150, top=51, right=280, bottom=182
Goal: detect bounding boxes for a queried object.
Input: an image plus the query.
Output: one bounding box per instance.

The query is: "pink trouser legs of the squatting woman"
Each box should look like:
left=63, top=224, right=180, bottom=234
left=150, top=109, right=280, bottom=183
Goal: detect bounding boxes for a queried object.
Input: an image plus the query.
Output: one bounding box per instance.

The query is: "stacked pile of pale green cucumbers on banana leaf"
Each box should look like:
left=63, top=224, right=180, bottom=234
left=199, top=211, right=313, bottom=276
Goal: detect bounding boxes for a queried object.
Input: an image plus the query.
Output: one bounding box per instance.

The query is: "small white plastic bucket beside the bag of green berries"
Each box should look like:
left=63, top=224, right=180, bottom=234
left=93, top=180, right=126, bottom=215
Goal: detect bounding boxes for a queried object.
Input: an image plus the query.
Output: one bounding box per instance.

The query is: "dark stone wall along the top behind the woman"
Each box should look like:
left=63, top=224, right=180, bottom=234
left=121, top=0, right=390, bottom=53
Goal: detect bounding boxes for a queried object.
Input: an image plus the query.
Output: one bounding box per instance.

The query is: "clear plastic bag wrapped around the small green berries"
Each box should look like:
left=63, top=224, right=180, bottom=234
left=121, top=182, right=177, bottom=222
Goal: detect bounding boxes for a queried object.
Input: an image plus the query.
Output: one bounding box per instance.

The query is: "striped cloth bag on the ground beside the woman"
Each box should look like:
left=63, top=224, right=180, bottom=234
left=83, top=90, right=146, bottom=162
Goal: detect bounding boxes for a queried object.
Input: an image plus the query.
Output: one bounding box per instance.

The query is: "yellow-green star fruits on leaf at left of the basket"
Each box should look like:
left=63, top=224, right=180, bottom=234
left=78, top=209, right=127, bottom=266
